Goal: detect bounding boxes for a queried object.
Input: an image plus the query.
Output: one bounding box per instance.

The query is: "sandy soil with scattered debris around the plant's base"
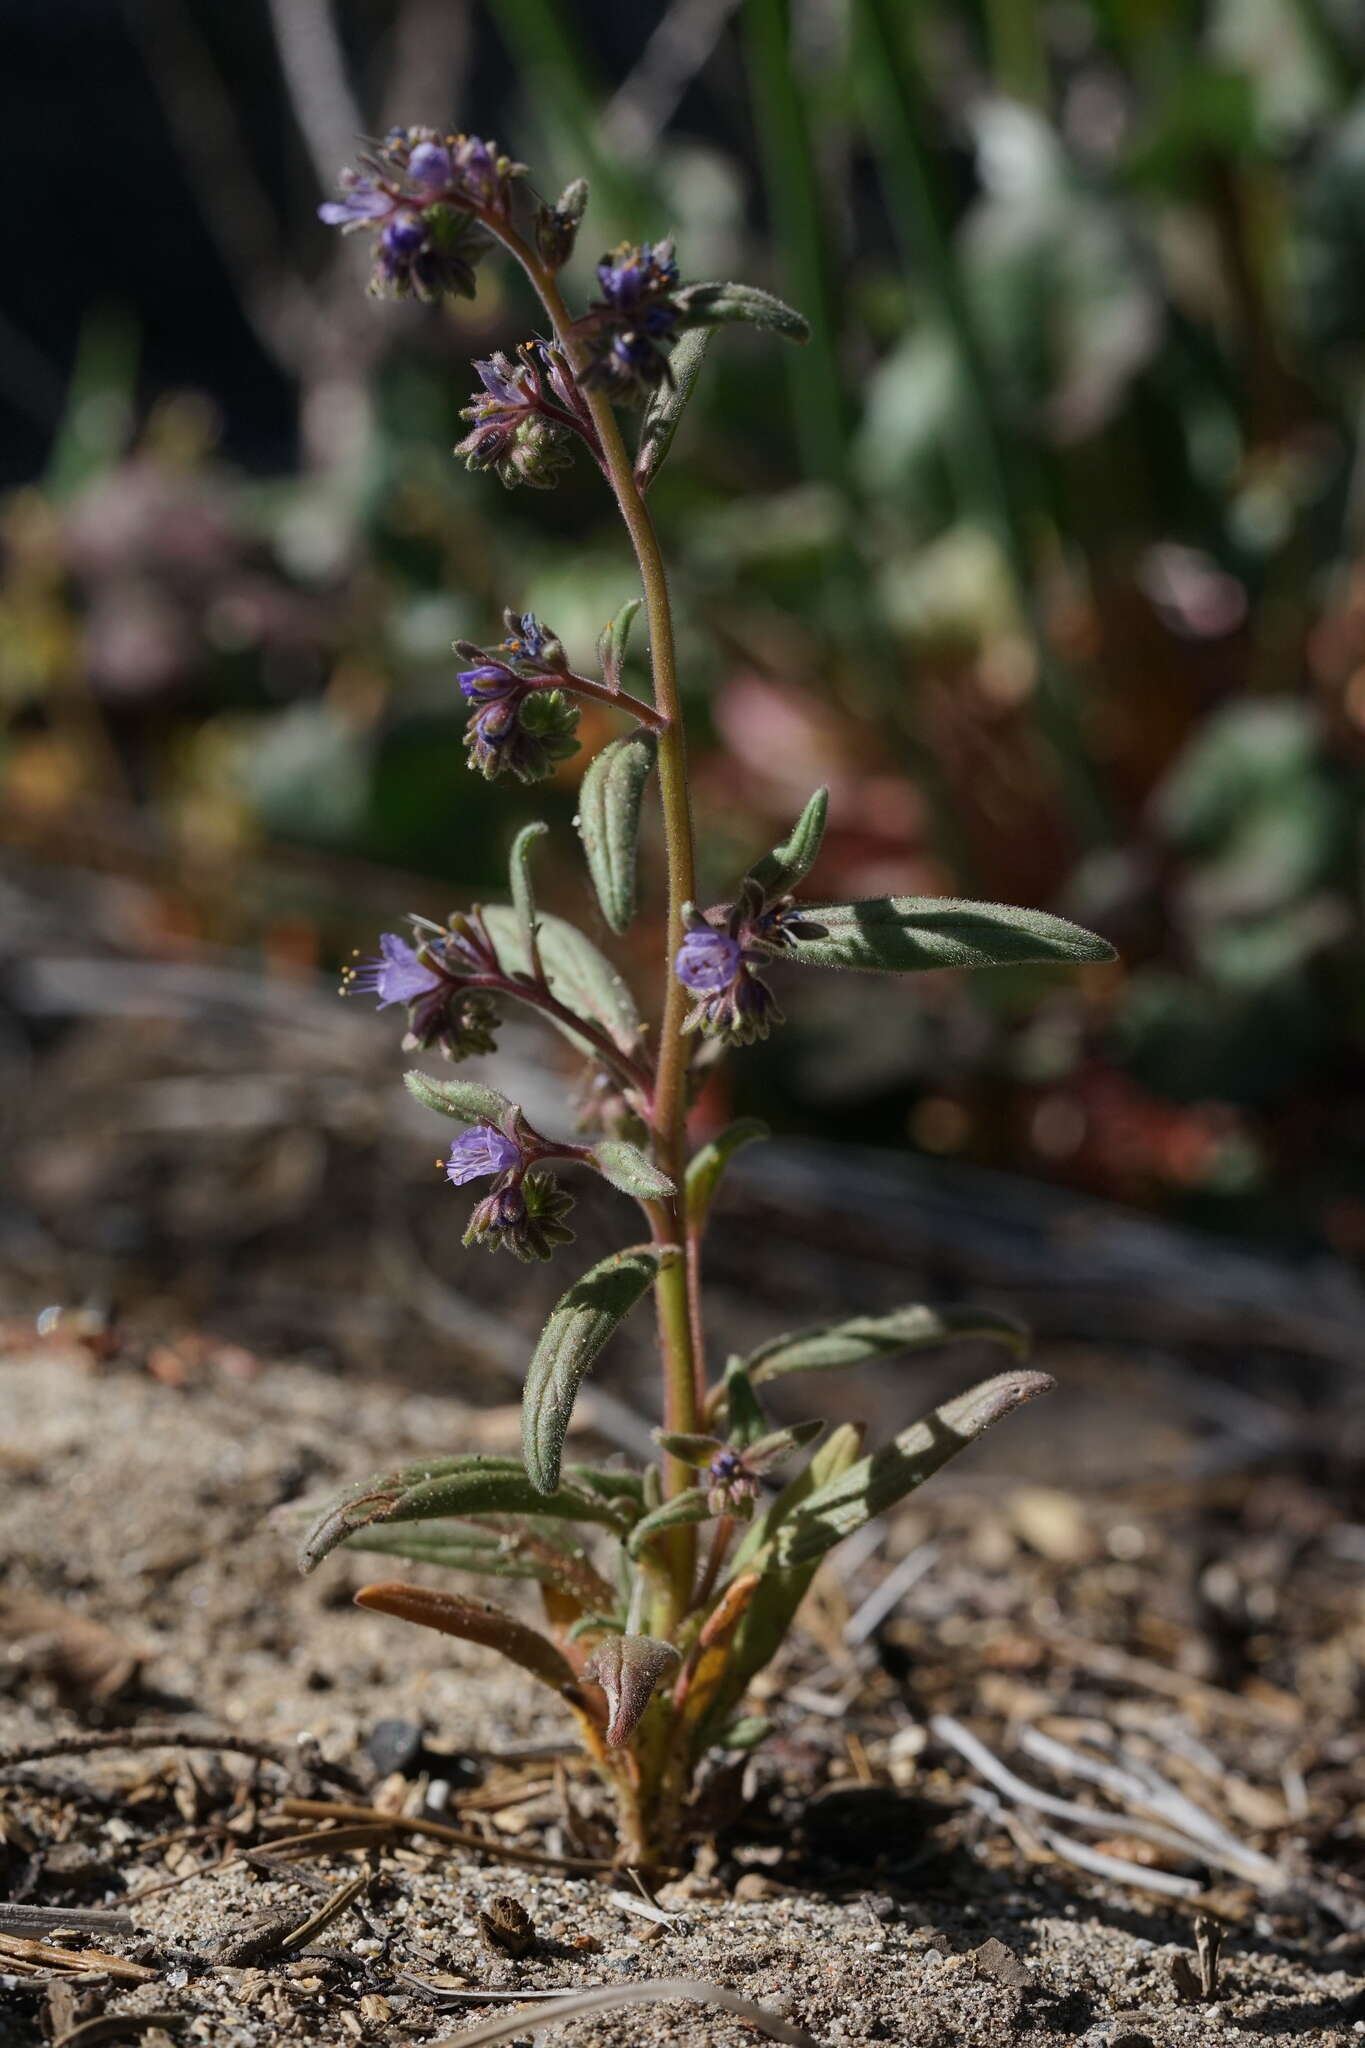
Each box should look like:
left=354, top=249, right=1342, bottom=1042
left=0, top=1333, right=1365, bottom=2048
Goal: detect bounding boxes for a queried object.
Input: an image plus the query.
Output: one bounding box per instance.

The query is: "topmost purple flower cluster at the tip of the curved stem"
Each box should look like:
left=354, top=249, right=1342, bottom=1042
left=317, top=129, right=524, bottom=301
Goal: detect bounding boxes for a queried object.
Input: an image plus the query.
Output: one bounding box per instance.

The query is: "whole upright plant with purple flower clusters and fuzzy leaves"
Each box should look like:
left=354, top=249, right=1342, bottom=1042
left=303, top=129, right=1109, bottom=1866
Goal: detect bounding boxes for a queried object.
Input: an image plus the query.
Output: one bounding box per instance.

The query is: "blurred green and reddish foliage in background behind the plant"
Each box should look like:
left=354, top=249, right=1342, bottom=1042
left=0, top=0, right=1365, bottom=1251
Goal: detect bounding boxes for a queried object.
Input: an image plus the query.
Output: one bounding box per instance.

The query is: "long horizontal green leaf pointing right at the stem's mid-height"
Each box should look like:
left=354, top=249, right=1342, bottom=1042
left=782, top=897, right=1115, bottom=975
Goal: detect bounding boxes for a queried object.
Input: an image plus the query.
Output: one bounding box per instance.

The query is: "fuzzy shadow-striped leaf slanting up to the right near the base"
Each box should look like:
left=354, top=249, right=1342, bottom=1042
left=776, top=1372, right=1056, bottom=1565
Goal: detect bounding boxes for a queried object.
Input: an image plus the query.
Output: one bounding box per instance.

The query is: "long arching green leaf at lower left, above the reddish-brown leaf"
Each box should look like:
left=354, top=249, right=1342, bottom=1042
left=299, top=1456, right=628, bottom=1573
